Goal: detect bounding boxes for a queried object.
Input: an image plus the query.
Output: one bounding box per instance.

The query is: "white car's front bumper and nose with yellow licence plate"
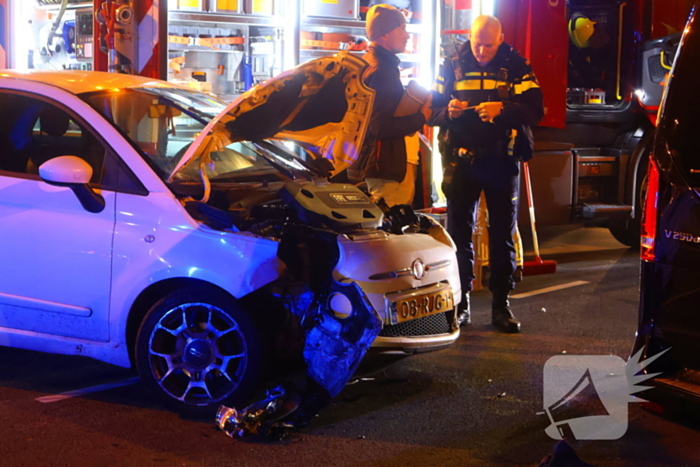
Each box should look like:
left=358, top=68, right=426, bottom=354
left=334, top=230, right=462, bottom=354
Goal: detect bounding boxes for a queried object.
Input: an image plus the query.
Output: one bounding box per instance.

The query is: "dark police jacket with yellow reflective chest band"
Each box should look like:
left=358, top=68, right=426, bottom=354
left=430, top=41, right=544, bottom=156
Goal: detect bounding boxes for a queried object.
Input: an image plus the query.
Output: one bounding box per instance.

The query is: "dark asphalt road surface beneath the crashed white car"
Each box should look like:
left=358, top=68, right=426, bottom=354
left=0, top=229, right=700, bottom=467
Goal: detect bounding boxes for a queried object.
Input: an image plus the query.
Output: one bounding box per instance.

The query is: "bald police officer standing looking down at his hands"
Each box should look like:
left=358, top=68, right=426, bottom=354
left=430, top=15, right=544, bottom=332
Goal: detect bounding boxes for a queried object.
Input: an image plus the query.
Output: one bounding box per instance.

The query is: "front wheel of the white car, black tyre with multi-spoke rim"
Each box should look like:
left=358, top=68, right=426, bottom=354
left=135, top=286, right=262, bottom=417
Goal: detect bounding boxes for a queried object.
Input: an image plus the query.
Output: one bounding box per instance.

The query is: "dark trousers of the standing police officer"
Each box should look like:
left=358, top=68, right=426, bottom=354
left=447, top=151, right=519, bottom=296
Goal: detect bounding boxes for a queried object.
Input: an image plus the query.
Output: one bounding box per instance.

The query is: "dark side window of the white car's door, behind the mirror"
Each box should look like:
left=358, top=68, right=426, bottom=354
left=0, top=93, right=138, bottom=190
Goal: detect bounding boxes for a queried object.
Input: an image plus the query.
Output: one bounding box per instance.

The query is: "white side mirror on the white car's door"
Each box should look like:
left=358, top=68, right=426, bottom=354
left=39, top=156, right=105, bottom=213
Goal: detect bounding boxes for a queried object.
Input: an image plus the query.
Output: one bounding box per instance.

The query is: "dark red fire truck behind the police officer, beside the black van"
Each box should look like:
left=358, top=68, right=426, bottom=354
left=495, top=0, right=693, bottom=246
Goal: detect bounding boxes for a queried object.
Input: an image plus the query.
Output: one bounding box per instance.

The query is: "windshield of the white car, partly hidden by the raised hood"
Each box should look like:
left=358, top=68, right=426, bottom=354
left=82, top=87, right=318, bottom=186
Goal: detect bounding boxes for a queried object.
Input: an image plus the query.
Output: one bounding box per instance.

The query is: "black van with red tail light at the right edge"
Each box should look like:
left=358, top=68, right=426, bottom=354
left=633, top=2, right=700, bottom=414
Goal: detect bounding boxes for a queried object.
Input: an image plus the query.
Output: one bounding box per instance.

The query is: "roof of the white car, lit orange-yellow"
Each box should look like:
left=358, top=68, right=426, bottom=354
left=0, top=70, right=180, bottom=94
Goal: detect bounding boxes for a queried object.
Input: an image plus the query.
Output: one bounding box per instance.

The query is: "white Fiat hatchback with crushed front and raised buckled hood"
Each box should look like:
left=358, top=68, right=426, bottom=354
left=0, top=54, right=461, bottom=412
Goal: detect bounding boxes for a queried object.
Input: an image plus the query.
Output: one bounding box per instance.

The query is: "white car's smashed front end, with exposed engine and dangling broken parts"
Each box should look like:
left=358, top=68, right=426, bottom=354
left=213, top=182, right=462, bottom=436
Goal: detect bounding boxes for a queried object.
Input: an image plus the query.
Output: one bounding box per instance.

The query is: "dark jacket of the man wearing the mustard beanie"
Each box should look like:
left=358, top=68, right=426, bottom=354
left=360, top=45, right=426, bottom=182
